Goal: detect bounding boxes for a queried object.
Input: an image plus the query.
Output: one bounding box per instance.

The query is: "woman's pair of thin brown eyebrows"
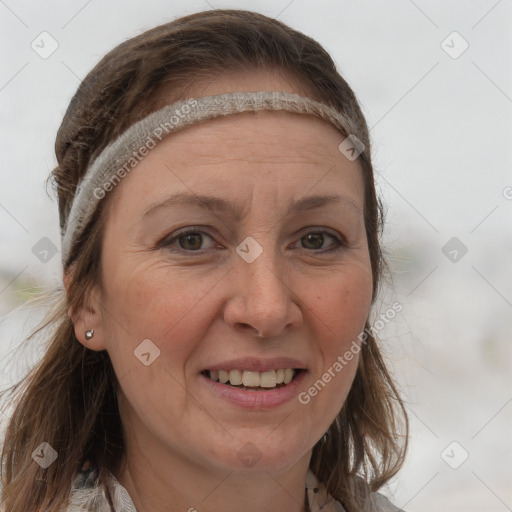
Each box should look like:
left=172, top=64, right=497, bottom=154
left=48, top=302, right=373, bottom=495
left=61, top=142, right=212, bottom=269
left=140, top=192, right=362, bottom=221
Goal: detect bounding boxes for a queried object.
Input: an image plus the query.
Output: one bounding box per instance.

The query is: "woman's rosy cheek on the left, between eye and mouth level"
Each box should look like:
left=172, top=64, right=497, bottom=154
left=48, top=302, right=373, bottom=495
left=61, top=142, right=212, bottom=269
left=100, top=267, right=222, bottom=372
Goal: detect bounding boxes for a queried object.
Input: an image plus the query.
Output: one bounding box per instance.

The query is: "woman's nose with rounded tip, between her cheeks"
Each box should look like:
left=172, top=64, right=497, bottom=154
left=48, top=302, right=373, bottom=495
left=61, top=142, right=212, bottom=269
left=224, top=246, right=303, bottom=338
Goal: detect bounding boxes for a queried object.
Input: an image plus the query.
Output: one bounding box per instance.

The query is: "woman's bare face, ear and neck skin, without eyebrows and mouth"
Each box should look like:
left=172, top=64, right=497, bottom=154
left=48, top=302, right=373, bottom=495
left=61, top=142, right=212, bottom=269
left=71, top=72, right=372, bottom=512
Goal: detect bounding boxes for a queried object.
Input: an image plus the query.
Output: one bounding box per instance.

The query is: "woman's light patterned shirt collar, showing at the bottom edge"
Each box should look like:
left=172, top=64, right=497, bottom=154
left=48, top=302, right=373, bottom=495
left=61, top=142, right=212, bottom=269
left=66, top=462, right=404, bottom=512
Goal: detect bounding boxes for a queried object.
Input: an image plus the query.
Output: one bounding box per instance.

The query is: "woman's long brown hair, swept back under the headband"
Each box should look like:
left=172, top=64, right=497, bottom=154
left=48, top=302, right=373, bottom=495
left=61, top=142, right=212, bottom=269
left=1, top=10, right=408, bottom=512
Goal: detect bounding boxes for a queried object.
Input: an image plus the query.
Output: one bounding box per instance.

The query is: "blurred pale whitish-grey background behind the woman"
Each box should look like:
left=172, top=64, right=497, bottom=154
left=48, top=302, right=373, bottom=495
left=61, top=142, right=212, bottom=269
left=0, top=0, right=512, bottom=512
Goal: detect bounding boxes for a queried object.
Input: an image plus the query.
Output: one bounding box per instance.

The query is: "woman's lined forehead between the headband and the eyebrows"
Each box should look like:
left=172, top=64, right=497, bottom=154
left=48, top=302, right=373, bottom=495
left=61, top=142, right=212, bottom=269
left=106, top=111, right=364, bottom=224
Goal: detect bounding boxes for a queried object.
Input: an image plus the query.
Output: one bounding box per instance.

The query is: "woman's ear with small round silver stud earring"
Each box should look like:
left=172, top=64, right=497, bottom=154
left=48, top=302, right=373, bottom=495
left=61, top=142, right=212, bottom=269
left=63, top=269, right=107, bottom=351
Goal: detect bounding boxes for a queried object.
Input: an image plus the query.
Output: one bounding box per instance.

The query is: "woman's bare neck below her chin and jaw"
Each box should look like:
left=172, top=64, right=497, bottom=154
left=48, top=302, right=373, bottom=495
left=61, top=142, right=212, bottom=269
left=117, top=445, right=311, bottom=512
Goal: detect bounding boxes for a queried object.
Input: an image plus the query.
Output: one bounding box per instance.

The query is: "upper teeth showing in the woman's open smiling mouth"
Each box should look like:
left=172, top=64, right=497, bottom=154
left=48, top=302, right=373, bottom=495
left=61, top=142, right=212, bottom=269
left=201, top=368, right=306, bottom=391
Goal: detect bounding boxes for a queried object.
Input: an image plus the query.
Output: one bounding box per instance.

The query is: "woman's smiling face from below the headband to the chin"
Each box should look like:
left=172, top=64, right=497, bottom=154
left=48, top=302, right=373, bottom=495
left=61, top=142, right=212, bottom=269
left=83, top=75, right=372, bottom=471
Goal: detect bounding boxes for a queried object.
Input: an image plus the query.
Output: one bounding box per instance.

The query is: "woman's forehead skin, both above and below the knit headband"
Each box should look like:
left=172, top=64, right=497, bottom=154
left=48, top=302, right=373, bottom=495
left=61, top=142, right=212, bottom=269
left=102, top=65, right=364, bottom=214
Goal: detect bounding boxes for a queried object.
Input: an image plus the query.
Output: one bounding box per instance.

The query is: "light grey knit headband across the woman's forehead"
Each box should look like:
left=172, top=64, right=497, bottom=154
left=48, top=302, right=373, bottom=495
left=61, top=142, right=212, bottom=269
left=61, top=91, right=355, bottom=266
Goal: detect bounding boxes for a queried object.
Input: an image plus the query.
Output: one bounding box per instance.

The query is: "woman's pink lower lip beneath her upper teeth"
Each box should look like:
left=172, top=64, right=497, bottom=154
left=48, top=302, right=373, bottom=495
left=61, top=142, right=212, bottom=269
left=200, top=370, right=307, bottom=409
